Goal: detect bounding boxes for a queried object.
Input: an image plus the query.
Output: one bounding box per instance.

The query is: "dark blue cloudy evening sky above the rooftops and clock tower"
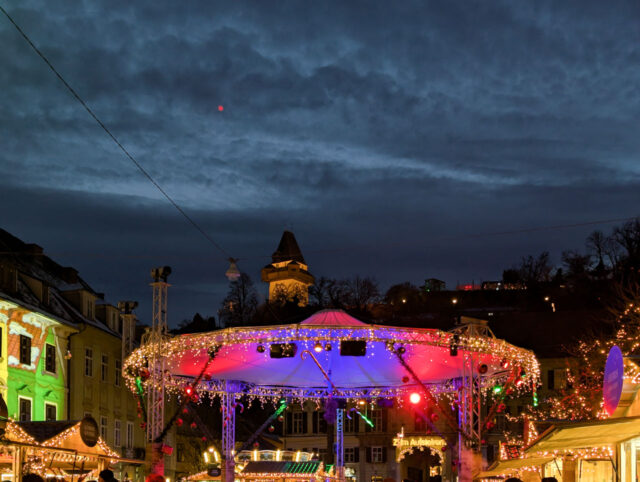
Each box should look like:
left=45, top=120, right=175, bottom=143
left=0, top=0, right=640, bottom=324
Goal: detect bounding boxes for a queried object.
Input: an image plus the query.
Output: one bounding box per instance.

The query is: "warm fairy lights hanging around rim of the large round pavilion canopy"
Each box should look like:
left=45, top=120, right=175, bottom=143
left=123, top=325, right=540, bottom=403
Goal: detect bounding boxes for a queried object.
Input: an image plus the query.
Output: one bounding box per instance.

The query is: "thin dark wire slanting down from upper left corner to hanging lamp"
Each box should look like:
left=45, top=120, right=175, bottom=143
left=0, top=5, right=231, bottom=259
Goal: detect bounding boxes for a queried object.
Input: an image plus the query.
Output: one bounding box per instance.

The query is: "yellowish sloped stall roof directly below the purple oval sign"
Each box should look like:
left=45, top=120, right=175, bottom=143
left=525, top=417, right=640, bottom=453
